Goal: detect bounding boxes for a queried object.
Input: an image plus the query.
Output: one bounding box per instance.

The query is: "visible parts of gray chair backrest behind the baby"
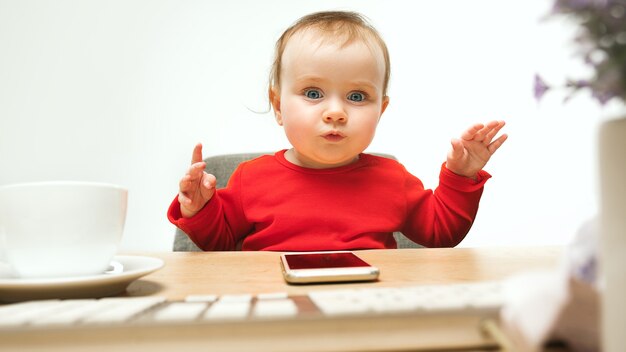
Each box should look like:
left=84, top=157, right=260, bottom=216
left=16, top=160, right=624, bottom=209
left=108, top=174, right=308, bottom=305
left=173, top=153, right=422, bottom=252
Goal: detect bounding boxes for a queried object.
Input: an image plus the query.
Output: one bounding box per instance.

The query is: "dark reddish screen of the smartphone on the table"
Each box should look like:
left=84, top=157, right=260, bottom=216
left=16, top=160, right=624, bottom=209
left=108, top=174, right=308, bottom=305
left=285, top=252, right=370, bottom=270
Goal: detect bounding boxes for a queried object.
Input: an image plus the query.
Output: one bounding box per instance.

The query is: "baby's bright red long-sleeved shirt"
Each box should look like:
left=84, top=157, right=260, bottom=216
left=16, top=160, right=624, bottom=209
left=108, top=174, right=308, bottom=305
left=168, top=150, right=491, bottom=251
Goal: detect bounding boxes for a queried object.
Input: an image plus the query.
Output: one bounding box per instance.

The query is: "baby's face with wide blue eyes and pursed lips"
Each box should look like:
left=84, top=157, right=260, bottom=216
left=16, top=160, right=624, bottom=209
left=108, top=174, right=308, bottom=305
left=272, top=31, right=388, bottom=168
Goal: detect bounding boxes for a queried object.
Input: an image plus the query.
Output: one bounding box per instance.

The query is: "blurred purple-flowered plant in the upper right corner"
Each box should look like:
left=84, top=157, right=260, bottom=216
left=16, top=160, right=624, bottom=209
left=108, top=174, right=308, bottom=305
left=534, top=0, right=626, bottom=105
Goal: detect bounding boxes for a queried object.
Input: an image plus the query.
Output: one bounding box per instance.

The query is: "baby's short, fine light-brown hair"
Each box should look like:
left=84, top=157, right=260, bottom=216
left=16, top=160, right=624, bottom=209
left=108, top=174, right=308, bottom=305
left=268, top=11, right=391, bottom=99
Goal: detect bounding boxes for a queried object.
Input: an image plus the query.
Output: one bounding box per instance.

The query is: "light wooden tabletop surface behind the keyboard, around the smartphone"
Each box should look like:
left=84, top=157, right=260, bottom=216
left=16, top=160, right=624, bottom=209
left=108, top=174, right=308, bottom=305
left=127, top=247, right=562, bottom=299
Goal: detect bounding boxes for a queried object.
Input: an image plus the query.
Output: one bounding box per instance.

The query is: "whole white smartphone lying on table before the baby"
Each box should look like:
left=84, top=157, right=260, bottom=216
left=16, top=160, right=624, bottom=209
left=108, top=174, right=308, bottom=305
left=280, top=251, right=380, bottom=284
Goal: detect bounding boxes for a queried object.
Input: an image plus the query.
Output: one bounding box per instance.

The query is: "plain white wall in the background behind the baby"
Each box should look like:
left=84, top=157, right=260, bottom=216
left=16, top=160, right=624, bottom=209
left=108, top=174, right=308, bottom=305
left=0, top=0, right=612, bottom=250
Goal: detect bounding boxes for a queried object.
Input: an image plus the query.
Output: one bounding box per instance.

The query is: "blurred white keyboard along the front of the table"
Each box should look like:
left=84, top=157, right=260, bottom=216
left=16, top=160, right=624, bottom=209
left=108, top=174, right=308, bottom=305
left=0, top=282, right=502, bottom=330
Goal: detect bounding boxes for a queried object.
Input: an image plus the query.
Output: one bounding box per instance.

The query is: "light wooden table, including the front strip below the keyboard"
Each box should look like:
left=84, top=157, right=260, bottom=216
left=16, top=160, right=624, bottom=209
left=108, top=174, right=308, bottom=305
left=0, top=247, right=563, bottom=352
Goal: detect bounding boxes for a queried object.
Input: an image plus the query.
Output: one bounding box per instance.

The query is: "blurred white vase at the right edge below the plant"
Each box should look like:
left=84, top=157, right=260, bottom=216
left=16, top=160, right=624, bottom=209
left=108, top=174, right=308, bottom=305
left=598, top=116, right=626, bottom=352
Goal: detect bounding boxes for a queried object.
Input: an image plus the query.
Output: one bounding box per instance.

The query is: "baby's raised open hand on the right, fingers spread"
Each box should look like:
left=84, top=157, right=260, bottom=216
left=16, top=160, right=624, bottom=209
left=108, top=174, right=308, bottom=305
left=446, top=121, right=508, bottom=179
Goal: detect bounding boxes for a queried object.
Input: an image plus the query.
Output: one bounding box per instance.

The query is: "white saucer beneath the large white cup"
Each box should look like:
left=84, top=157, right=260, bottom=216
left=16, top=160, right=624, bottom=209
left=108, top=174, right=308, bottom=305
left=0, top=255, right=163, bottom=302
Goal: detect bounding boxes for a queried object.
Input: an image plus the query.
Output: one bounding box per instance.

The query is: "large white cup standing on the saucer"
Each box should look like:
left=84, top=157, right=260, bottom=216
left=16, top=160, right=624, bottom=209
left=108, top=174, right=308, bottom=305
left=0, top=181, right=128, bottom=278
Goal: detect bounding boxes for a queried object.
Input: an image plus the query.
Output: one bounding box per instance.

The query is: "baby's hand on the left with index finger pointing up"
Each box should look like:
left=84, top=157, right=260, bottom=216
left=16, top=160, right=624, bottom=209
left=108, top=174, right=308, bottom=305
left=178, top=143, right=217, bottom=218
